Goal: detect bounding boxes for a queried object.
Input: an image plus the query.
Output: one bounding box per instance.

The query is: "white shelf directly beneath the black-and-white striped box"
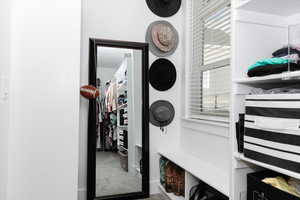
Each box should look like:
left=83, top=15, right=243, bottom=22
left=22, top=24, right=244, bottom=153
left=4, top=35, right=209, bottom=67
left=234, top=153, right=300, bottom=179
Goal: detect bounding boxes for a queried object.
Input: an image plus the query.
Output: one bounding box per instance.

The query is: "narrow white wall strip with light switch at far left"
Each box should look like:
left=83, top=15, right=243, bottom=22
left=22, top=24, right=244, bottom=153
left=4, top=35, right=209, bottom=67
left=0, top=0, right=11, bottom=200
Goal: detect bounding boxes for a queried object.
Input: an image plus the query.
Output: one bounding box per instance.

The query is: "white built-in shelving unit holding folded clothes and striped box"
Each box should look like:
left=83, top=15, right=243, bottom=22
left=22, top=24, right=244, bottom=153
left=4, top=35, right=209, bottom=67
left=230, top=0, right=300, bottom=200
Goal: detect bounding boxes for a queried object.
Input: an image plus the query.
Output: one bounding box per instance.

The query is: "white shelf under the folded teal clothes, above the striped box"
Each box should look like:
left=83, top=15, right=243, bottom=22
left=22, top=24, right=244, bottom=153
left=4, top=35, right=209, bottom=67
left=235, top=71, right=300, bottom=85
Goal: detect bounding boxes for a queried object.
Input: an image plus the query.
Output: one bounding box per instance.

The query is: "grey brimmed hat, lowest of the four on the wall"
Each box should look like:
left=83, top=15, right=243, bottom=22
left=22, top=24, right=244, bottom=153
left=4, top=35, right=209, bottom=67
left=150, top=100, right=175, bottom=127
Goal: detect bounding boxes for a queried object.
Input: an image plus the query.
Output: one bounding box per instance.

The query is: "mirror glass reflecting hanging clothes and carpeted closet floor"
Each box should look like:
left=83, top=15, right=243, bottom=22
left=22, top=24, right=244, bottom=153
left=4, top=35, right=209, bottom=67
left=95, top=46, right=142, bottom=197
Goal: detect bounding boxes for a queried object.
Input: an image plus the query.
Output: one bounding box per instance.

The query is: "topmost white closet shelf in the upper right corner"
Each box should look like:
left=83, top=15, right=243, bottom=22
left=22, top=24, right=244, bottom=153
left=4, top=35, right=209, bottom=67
left=236, top=0, right=300, bottom=17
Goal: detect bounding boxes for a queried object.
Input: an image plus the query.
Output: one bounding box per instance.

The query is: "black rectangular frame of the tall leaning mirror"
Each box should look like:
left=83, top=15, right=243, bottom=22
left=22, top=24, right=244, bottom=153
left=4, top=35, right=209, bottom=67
left=87, top=38, right=150, bottom=200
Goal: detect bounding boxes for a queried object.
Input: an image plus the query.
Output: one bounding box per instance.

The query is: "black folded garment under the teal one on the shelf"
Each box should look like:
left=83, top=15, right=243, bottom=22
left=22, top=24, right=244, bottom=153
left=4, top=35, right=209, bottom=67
left=247, top=63, right=300, bottom=77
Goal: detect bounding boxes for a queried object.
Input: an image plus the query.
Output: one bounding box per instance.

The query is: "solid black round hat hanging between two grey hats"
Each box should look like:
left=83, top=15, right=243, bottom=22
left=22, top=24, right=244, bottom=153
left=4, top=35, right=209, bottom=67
left=149, top=58, right=177, bottom=91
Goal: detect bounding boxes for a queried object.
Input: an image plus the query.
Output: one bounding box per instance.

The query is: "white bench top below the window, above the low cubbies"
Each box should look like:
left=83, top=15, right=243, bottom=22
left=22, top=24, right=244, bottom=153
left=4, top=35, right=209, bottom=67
left=158, top=150, right=229, bottom=196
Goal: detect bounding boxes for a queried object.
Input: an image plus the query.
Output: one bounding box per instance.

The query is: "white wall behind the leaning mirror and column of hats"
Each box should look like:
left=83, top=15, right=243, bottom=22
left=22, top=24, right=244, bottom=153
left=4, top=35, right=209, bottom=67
left=79, top=0, right=184, bottom=199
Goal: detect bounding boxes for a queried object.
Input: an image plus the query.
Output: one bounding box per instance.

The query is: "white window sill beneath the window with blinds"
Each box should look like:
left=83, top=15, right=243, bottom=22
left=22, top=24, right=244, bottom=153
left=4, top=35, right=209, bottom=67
left=182, top=118, right=230, bottom=139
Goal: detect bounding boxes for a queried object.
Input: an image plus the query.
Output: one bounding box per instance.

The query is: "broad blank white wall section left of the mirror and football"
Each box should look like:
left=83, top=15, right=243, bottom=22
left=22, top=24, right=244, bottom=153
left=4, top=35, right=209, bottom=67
left=8, top=0, right=81, bottom=200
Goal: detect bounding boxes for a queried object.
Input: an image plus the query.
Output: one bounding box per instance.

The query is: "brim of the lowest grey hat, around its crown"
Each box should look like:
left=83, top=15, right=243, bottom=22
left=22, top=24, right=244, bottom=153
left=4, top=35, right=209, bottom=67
left=149, top=100, right=175, bottom=127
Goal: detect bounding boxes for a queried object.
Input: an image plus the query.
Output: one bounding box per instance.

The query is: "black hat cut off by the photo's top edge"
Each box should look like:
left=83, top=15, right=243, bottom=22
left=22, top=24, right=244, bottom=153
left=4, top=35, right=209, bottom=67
left=146, top=0, right=181, bottom=17
